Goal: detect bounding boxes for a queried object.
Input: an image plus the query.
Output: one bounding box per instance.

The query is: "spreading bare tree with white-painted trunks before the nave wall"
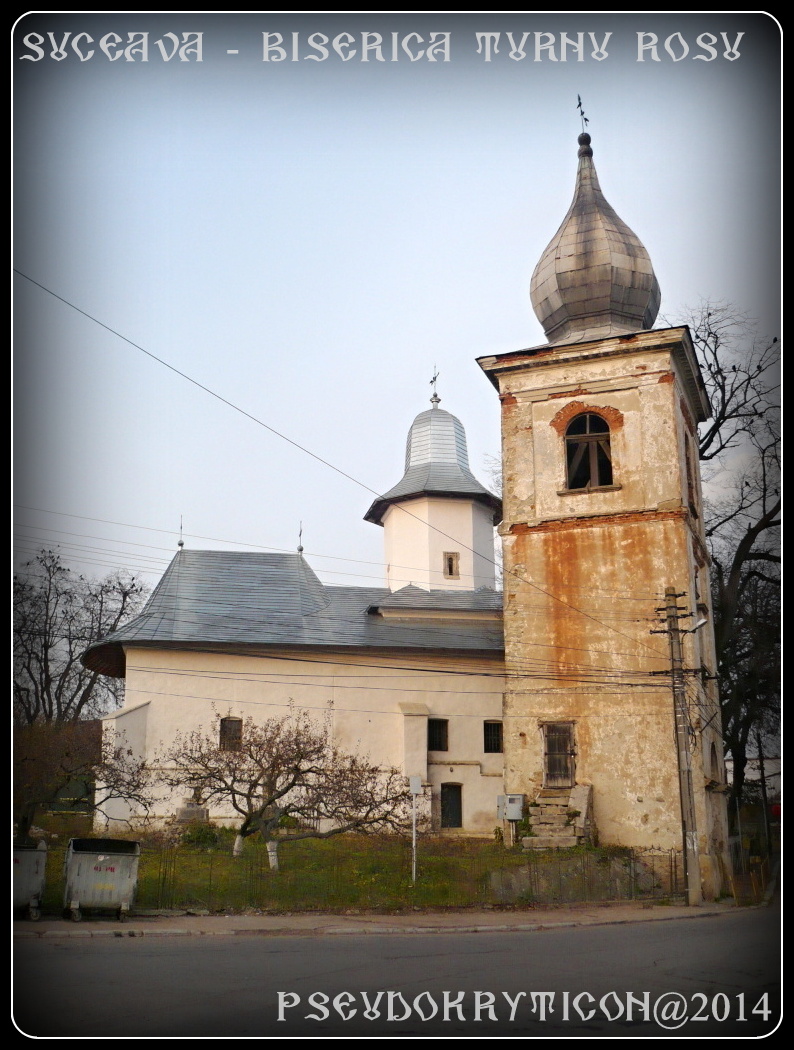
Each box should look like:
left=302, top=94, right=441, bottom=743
left=158, top=713, right=411, bottom=868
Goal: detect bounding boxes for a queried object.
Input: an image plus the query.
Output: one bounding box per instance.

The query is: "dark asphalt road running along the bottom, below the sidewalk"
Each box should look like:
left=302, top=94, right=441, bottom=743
left=14, top=908, right=780, bottom=1038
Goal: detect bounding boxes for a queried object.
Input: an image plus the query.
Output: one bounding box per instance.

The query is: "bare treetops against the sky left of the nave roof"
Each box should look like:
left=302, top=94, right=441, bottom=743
left=14, top=550, right=148, bottom=726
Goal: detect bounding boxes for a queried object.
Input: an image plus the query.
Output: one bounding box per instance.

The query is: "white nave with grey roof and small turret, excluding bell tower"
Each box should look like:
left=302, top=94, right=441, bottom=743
left=84, top=394, right=504, bottom=836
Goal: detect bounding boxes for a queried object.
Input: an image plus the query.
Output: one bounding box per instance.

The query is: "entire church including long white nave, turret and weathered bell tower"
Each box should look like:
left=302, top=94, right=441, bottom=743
left=84, top=133, right=727, bottom=897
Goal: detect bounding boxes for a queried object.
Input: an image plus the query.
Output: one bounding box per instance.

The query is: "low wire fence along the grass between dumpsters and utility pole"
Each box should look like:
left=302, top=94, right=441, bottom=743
left=35, top=843, right=684, bottom=911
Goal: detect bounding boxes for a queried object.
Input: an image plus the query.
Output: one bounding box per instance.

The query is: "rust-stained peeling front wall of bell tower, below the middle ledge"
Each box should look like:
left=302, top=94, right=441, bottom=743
left=505, top=518, right=685, bottom=848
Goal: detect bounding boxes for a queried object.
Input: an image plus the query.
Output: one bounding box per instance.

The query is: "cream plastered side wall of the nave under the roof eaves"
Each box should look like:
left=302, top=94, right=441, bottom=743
left=102, top=648, right=504, bottom=835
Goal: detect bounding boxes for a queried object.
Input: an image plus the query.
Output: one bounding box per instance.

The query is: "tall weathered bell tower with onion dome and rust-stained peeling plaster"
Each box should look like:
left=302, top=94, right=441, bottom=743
left=479, top=133, right=727, bottom=897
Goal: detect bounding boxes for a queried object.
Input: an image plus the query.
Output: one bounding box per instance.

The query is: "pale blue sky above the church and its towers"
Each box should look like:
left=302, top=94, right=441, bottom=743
left=14, top=12, right=780, bottom=585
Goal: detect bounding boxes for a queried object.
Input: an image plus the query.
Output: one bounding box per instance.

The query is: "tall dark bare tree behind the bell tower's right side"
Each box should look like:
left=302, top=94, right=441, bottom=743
left=688, top=302, right=780, bottom=813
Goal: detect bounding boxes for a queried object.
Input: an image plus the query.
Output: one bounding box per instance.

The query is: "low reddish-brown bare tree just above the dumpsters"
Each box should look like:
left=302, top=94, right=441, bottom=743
left=14, top=720, right=153, bottom=839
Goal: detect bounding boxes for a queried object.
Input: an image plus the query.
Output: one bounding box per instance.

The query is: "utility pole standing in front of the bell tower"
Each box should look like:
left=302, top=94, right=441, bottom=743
left=665, top=587, right=703, bottom=907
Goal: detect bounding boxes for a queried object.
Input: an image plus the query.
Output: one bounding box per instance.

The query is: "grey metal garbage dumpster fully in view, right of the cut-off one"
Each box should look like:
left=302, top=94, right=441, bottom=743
left=63, top=839, right=141, bottom=922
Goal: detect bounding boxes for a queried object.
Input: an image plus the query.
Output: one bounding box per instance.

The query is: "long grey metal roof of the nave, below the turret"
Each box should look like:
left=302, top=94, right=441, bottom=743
left=83, top=550, right=504, bottom=677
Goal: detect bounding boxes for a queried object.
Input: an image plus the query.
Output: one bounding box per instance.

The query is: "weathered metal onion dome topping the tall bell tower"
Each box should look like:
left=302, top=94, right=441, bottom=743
left=529, top=131, right=661, bottom=343
